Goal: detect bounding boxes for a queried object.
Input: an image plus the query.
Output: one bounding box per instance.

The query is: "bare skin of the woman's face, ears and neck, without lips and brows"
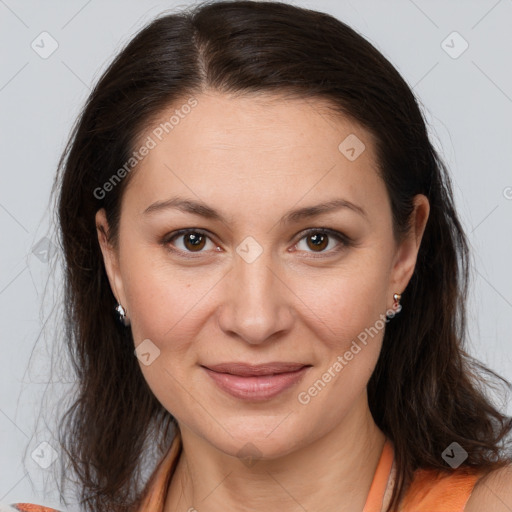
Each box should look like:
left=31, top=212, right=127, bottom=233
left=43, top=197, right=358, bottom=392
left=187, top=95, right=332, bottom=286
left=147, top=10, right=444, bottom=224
left=96, top=92, right=429, bottom=512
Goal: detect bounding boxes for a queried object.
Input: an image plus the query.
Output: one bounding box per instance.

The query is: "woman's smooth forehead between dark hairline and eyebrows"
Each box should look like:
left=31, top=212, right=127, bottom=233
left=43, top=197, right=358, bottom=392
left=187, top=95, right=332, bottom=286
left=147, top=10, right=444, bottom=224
left=123, top=93, right=383, bottom=222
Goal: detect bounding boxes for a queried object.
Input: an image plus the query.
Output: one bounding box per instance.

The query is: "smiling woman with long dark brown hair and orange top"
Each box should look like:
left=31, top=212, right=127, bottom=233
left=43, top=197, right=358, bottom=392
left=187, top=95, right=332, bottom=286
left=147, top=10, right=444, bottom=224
left=5, top=2, right=512, bottom=512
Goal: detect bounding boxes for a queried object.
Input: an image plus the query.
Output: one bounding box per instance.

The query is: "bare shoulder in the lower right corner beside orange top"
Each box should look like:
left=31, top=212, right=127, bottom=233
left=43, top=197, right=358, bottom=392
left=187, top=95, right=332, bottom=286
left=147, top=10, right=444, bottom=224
left=464, top=466, right=512, bottom=512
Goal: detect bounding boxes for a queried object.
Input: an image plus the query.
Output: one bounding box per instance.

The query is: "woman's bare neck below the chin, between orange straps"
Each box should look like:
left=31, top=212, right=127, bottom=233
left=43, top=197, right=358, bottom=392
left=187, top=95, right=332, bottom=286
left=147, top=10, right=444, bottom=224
left=164, top=394, right=385, bottom=512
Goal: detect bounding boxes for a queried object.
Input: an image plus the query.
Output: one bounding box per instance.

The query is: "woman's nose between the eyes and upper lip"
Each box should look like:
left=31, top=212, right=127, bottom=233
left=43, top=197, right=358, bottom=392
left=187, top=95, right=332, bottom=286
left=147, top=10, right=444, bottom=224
left=217, top=243, right=294, bottom=345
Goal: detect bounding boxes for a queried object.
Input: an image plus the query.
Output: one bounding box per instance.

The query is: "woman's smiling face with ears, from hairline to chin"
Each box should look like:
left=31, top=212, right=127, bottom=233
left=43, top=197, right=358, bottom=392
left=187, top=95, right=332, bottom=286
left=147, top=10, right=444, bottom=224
left=97, top=92, right=428, bottom=458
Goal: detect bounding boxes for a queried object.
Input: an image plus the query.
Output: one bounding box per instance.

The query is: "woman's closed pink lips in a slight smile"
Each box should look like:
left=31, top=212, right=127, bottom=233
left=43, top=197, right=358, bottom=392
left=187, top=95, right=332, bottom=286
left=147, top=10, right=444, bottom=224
left=202, top=363, right=311, bottom=401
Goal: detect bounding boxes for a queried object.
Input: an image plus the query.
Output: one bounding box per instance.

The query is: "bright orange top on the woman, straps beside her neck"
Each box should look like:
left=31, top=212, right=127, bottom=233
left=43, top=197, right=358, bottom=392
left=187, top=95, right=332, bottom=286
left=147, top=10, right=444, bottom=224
left=138, top=431, right=480, bottom=512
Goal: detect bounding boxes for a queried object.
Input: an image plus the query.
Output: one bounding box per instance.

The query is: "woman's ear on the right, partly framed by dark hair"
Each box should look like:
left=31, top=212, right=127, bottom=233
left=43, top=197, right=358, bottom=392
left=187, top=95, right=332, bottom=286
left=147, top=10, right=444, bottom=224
left=388, top=194, right=430, bottom=297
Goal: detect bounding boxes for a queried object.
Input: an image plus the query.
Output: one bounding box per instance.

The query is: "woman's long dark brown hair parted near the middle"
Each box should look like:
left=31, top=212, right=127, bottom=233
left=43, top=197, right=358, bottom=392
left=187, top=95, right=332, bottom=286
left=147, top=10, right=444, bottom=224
left=56, top=1, right=512, bottom=512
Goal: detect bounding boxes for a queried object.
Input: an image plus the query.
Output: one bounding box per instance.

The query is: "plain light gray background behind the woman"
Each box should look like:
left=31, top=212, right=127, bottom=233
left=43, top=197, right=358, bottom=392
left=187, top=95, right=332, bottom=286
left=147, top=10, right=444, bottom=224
left=0, top=0, right=512, bottom=506
